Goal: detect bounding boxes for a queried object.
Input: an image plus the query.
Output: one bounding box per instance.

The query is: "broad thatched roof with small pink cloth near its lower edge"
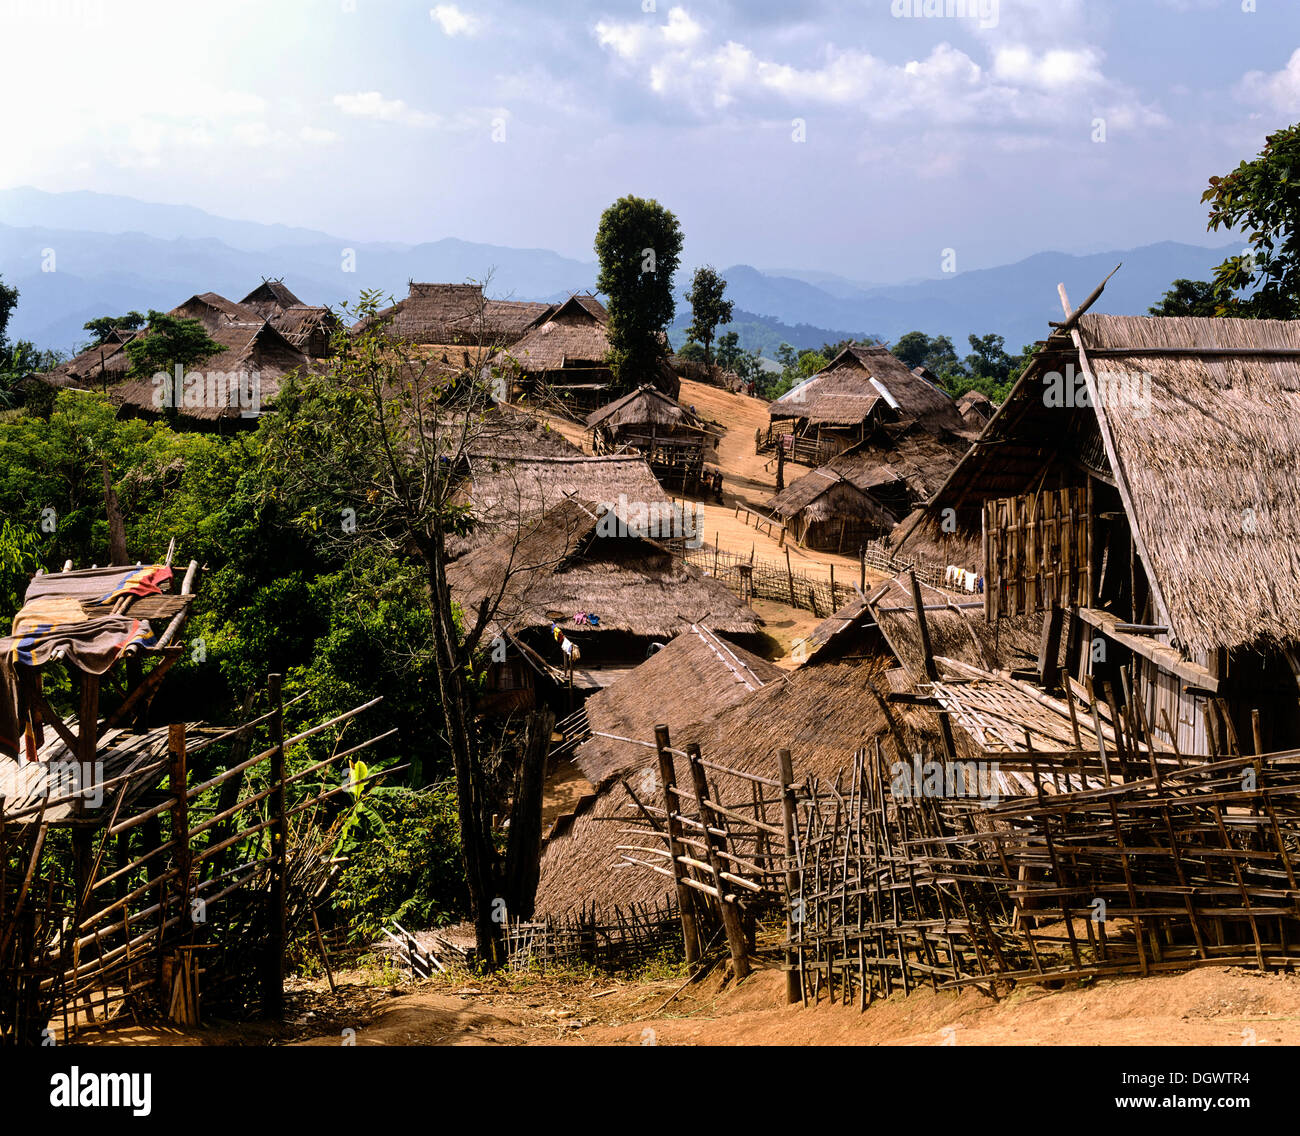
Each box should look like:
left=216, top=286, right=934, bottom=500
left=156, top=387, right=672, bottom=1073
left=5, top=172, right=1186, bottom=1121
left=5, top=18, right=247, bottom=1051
left=447, top=498, right=761, bottom=638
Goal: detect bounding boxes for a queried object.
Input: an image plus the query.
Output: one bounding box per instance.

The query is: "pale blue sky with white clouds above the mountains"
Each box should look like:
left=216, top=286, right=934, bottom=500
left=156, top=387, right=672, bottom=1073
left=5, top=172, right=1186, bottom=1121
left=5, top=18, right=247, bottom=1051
left=0, top=0, right=1300, bottom=282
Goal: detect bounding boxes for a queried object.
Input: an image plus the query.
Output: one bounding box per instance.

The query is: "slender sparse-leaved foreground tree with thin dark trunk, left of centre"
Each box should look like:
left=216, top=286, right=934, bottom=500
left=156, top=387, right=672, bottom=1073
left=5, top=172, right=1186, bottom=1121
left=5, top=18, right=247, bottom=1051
left=263, top=292, right=559, bottom=966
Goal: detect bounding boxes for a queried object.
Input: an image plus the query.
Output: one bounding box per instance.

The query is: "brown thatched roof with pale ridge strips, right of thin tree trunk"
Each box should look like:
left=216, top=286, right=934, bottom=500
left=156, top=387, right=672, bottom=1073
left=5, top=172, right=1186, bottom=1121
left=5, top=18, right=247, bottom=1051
left=573, top=624, right=785, bottom=785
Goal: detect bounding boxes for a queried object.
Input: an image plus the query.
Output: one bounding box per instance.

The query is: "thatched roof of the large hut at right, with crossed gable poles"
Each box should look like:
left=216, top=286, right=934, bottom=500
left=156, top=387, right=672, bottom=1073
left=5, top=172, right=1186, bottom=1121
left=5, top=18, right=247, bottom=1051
left=900, top=313, right=1300, bottom=652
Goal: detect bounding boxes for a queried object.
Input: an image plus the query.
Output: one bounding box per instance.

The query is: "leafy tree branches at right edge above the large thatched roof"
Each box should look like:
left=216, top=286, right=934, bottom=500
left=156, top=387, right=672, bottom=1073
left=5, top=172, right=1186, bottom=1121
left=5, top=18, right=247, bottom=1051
left=1201, top=125, right=1300, bottom=320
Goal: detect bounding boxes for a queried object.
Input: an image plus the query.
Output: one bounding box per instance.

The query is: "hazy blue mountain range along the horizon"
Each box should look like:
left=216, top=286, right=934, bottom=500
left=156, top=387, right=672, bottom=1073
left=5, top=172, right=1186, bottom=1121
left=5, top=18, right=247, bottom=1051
left=0, top=187, right=1240, bottom=357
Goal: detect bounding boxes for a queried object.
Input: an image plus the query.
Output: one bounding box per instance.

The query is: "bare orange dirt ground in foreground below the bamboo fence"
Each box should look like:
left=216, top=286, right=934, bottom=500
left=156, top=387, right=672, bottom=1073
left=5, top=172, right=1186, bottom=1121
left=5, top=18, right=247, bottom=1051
left=276, top=968, right=1300, bottom=1045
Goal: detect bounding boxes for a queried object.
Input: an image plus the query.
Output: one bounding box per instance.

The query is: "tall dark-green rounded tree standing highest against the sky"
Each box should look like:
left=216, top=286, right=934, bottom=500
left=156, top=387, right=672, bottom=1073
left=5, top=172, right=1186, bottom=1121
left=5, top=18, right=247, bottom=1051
left=595, top=196, right=683, bottom=386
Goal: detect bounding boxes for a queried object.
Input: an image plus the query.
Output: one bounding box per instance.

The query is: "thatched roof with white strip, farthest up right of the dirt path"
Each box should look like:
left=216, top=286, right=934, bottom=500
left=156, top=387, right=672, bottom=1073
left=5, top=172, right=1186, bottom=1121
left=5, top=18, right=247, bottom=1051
left=767, top=346, right=965, bottom=430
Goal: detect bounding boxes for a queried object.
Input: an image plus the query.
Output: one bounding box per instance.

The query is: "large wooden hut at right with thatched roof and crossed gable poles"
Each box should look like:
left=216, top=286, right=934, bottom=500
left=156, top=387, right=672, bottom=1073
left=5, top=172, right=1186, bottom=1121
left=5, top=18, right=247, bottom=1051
left=898, top=305, right=1300, bottom=754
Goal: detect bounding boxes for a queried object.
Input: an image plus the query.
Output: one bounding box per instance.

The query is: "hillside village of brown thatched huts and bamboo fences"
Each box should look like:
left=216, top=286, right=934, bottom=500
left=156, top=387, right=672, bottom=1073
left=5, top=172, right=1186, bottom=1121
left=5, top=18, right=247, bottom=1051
left=0, top=214, right=1300, bottom=1055
